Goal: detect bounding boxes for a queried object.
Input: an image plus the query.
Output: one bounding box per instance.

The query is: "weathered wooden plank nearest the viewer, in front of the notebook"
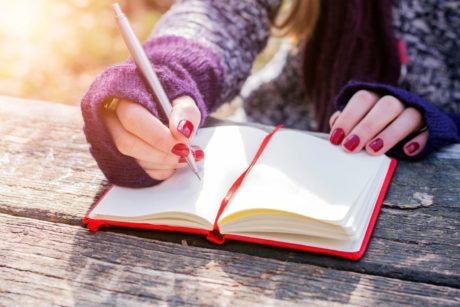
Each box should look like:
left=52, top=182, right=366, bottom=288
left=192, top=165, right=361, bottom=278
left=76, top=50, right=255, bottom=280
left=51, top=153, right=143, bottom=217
left=0, top=215, right=460, bottom=306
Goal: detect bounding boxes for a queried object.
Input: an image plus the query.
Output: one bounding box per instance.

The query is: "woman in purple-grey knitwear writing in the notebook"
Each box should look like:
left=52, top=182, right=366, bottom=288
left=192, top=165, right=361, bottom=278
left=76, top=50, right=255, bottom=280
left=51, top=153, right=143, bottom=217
left=82, top=0, right=460, bottom=187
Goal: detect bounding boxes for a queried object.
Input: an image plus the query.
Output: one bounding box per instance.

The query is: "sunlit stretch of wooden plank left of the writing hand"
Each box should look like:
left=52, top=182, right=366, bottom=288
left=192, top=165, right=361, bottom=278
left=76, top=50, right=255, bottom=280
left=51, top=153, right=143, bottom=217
left=0, top=98, right=107, bottom=224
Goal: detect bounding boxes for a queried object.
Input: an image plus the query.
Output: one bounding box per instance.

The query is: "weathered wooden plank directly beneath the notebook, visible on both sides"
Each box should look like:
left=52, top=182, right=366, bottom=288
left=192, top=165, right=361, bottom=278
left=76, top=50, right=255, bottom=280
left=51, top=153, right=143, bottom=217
left=0, top=98, right=460, bottom=286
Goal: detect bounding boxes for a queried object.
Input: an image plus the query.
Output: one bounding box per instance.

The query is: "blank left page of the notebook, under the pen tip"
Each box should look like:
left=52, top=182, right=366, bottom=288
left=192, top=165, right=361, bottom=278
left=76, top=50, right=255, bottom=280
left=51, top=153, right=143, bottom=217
left=90, top=126, right=266, bottom=224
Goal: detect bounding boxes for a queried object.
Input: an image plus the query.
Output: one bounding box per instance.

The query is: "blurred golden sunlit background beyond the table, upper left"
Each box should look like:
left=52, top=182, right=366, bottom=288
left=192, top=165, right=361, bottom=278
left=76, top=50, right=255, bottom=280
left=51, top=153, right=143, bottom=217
left=0, top=0, right=165, bottom=104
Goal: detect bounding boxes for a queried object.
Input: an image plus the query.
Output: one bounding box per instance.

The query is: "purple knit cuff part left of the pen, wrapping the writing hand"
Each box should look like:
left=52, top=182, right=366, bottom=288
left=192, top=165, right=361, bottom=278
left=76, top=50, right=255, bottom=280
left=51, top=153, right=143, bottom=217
left=81, top=64, right=161, bottom=187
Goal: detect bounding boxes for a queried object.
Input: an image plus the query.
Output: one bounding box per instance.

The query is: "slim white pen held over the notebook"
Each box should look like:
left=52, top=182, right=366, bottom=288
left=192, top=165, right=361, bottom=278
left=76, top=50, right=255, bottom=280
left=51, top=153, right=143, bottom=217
left=113, top=3, right=201, bottom=180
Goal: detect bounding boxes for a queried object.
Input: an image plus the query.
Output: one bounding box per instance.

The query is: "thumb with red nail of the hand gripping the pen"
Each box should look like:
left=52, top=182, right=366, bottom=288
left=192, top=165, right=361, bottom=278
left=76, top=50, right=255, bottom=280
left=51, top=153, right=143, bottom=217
left=169, top=96, right=201, bottom=143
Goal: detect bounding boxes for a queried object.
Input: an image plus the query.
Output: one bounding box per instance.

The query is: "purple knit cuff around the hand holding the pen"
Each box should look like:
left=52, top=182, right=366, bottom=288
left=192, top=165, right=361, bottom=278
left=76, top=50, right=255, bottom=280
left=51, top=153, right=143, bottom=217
left=81, top=37, right=225, bottom=187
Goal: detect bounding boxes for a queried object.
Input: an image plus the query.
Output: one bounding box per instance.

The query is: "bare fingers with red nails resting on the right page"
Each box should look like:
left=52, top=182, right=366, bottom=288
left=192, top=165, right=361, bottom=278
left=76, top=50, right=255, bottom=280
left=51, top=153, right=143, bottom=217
left=329, top=90, right=428, bottom=156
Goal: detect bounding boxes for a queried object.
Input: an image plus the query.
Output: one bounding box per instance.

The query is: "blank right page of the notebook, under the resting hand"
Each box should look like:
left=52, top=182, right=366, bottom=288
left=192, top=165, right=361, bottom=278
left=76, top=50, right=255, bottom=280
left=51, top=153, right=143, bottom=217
left=221, top=130, right=390, bottom=223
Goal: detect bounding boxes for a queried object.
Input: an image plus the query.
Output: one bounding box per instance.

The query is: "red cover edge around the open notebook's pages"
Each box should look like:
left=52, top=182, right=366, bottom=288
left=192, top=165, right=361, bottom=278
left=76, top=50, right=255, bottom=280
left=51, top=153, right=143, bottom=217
left=83, top=158, right=397, bottom=260
